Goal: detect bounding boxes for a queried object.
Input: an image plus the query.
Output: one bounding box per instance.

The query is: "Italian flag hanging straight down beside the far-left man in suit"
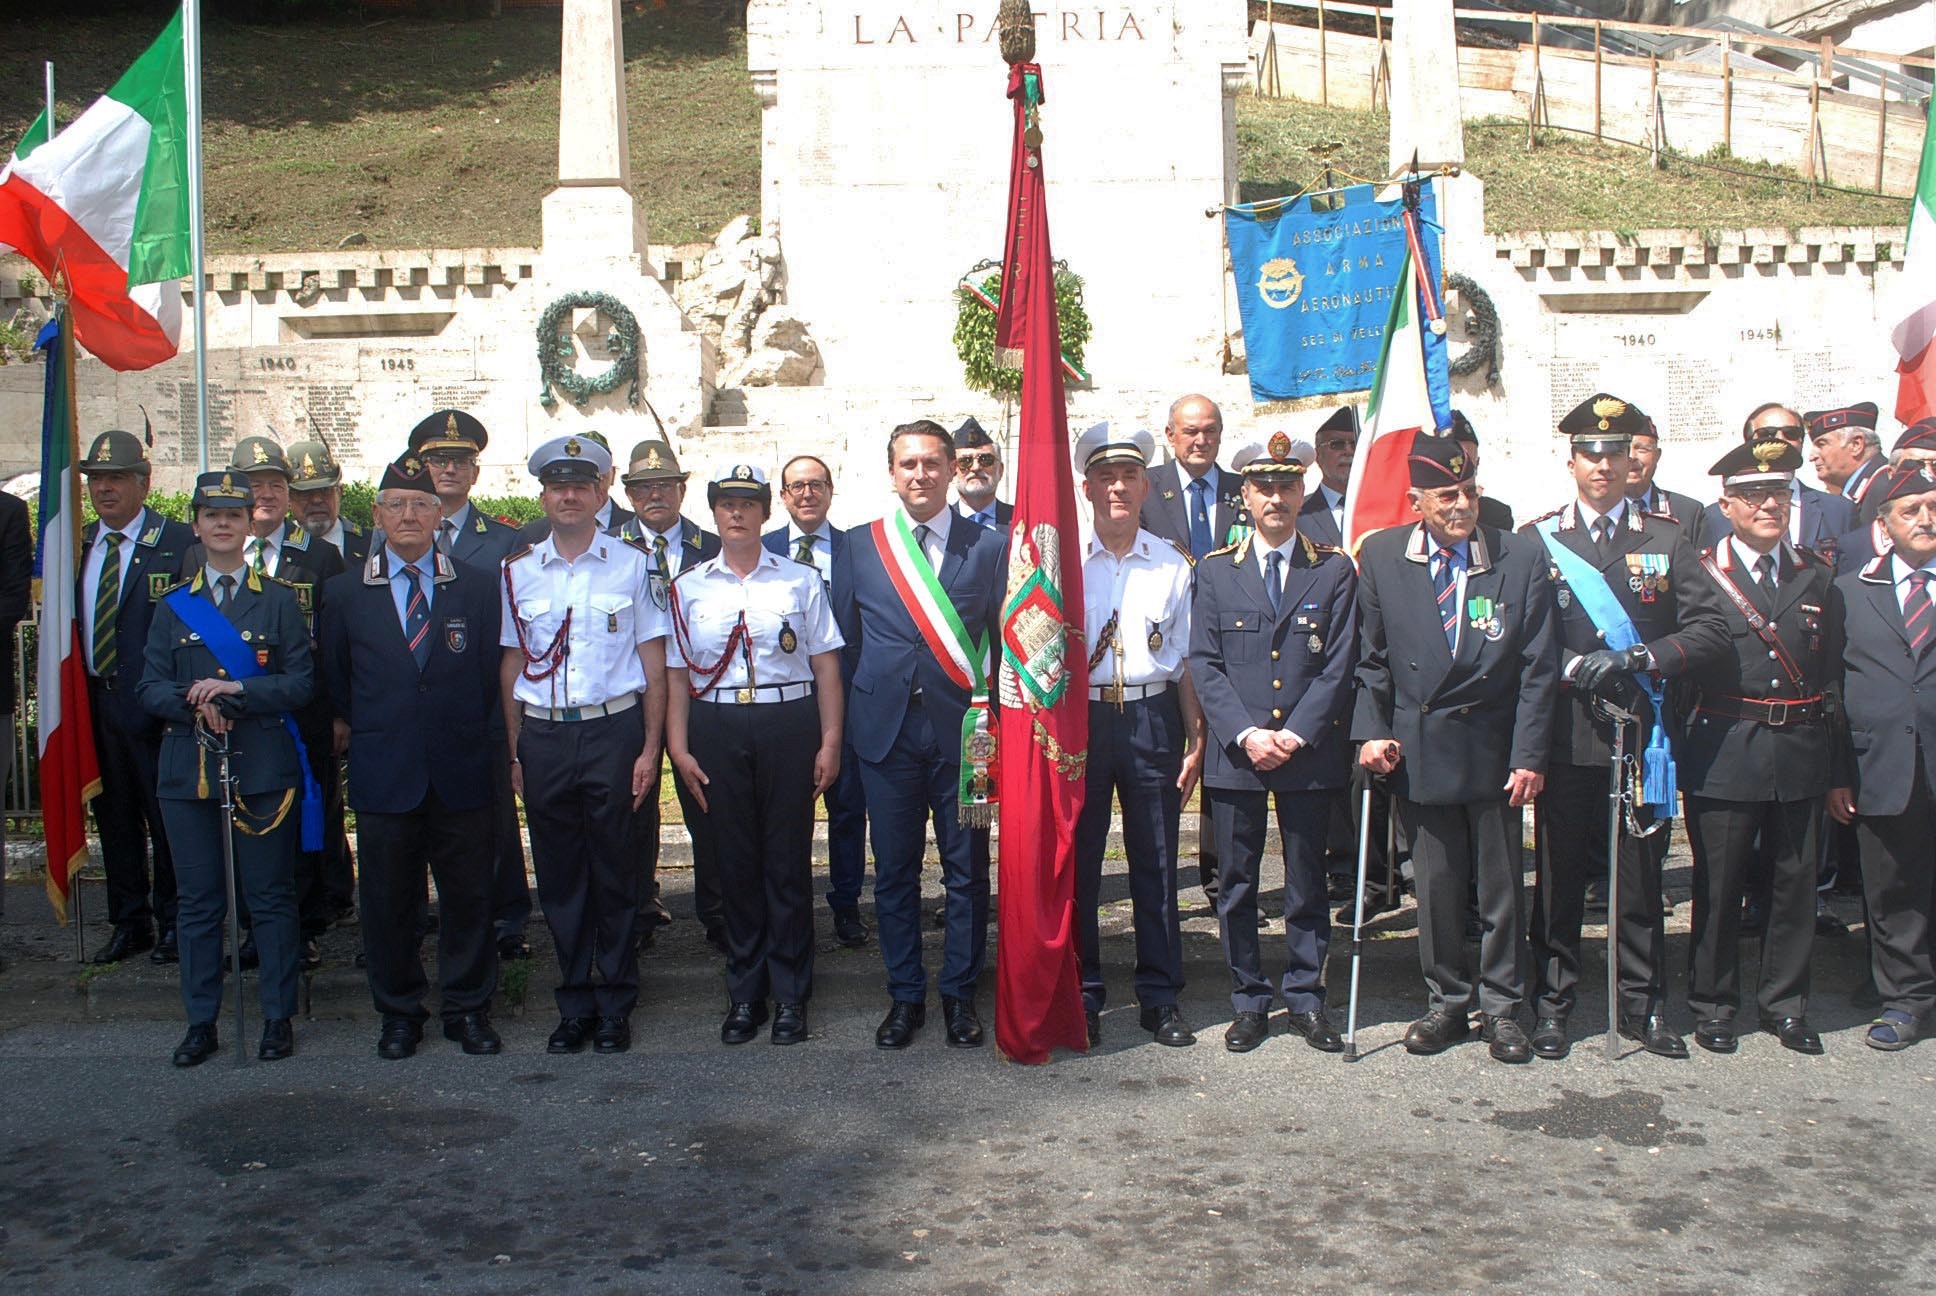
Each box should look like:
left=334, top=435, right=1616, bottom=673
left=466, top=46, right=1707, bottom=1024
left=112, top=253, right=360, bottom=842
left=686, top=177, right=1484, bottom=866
left=35, top=310, right=101, bottom=922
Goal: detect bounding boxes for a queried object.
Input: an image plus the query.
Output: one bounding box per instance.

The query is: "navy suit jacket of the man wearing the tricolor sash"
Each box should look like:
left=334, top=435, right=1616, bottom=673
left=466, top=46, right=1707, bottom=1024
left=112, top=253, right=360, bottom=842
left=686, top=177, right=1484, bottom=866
left=832, top=517, right=1009, bottom=761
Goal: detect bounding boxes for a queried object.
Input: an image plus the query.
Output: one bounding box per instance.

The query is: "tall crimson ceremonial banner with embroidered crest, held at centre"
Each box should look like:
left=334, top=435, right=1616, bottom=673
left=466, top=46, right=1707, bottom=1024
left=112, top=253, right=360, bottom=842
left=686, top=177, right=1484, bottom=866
left=995, top=32, right=1088, bottom=1064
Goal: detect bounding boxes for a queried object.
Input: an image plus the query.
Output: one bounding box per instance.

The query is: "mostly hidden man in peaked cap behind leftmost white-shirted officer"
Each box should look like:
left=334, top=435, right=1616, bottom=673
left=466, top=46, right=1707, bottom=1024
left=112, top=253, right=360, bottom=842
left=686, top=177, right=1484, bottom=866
left=410, top=409, right=530, bottom=961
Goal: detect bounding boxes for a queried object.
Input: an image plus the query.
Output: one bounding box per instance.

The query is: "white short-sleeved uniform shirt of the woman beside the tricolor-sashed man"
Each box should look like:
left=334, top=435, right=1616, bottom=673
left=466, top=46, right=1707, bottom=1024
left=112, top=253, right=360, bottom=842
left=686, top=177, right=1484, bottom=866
left=666, top=546, right=846, bottom=685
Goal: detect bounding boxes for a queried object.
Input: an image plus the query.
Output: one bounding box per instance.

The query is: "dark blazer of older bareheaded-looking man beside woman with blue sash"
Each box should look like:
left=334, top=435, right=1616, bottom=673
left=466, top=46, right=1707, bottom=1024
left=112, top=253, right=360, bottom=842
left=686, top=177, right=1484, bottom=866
left=319, top=548, right=503, bottom=814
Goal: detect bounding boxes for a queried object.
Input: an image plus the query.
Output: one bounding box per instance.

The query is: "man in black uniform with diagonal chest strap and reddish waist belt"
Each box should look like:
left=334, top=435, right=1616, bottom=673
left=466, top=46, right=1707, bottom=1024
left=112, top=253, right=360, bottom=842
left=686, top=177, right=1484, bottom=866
left=1675, top=440, right=1845, bottom=1054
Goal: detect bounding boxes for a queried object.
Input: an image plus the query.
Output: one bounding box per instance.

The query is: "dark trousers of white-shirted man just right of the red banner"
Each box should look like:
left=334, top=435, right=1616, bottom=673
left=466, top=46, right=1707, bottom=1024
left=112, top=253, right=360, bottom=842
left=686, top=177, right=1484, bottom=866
left=1076, top=688, right=1185, bottom=1013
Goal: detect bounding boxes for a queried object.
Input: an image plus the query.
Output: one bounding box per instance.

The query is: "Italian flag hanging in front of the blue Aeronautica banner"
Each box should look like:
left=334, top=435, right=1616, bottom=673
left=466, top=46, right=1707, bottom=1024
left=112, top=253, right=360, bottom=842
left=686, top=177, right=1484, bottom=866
left=1344, top=207, right=1452, bottom=556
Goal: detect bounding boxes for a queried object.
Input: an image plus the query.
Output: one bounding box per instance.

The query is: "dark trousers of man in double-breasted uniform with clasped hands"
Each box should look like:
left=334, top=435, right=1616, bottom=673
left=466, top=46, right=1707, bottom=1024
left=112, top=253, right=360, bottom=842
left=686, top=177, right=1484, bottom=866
left=1204, top=788, right=1338, bottom=1013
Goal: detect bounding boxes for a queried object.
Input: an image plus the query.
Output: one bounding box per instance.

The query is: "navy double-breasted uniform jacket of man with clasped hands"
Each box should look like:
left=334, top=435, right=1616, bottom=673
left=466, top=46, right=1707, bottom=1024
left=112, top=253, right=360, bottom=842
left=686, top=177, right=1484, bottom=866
left=1191, top=537, right=1357, bottom=792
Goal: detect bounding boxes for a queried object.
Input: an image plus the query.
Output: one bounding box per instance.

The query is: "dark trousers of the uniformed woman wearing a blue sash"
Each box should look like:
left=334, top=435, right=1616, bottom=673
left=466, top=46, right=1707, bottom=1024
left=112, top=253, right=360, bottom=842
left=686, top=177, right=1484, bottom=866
left=161, top=792, right=302, bottom=1025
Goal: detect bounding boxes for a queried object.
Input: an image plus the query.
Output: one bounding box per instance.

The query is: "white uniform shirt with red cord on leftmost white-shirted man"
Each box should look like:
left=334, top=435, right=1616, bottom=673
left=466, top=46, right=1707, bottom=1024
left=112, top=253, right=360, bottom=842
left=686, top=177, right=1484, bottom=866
left=498, top=535, right=668, bottom=707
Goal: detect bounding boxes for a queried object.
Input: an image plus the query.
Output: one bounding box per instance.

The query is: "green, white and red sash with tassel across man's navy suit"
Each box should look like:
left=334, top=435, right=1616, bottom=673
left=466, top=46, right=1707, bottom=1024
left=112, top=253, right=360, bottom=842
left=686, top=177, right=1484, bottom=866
left=873, top=509, right=997, bottom=827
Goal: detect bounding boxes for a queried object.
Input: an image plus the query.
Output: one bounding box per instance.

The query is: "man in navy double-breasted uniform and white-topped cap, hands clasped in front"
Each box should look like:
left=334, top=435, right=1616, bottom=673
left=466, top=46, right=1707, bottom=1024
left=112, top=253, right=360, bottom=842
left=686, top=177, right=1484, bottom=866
left=1189, top=432, right=1357, bottom=1052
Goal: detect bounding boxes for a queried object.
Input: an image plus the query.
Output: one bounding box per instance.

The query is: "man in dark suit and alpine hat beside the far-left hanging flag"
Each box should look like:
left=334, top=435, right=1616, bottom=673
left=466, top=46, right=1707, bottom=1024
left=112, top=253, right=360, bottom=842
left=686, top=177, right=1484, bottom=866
left=75, top=430, right=196, bottom=963
